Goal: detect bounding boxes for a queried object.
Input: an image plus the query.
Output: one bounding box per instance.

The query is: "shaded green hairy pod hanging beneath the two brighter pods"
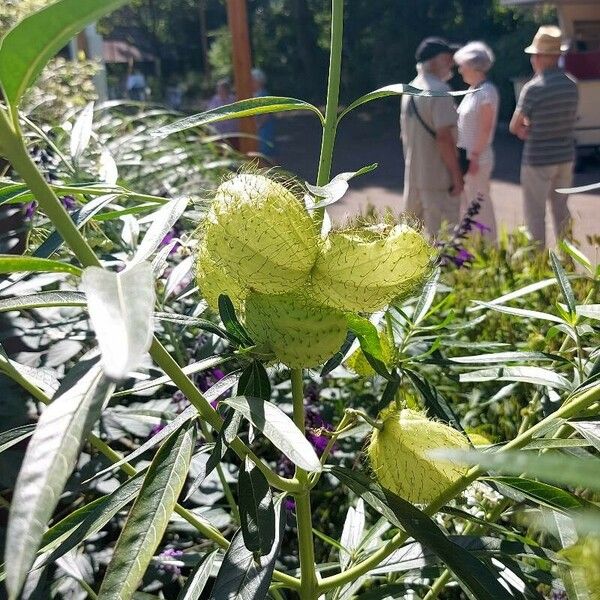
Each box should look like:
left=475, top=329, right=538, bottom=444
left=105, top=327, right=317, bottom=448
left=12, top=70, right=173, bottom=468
left=245, top=292, right=347, bottom=369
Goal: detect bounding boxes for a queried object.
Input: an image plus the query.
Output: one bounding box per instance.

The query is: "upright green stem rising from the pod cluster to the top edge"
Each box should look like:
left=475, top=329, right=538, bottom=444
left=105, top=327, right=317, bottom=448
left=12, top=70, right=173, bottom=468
left=317, top=0, right=344, bottom=189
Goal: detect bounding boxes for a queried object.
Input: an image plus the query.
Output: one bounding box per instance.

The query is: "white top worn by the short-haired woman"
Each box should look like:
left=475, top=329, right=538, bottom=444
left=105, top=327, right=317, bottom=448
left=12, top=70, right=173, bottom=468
left=457, top=81, right=500, bottom=163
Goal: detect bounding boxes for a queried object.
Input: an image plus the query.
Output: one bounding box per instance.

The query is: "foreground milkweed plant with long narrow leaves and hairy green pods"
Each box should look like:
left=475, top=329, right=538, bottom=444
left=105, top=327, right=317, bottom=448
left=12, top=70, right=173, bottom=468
left=0, top=0, right=600, bottom=600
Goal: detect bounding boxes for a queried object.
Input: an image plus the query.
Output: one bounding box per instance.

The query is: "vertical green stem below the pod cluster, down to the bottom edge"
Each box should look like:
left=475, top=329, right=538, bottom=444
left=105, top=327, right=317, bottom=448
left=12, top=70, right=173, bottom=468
left=290, top=369, right=318, bottom=600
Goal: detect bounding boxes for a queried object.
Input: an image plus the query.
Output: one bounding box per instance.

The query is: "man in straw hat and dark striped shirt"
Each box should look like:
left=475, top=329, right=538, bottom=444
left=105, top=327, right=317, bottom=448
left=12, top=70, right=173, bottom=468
left=510, top=26, right=579, bottom=245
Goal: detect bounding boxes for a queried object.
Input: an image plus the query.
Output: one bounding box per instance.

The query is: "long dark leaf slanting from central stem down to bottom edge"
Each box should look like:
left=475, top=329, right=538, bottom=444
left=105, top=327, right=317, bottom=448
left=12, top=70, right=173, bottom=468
left=331, top=466, right=514, bottom=600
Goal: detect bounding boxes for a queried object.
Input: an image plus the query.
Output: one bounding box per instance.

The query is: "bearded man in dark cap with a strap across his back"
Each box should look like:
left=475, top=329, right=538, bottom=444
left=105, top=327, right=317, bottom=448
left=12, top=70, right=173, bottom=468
left=400, top=37, right=463, bottom=236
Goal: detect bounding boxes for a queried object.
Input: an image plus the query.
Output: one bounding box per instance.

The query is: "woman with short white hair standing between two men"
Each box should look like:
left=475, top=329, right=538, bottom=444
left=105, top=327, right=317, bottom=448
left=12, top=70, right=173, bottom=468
left=454, top=42, right=500, bottom=240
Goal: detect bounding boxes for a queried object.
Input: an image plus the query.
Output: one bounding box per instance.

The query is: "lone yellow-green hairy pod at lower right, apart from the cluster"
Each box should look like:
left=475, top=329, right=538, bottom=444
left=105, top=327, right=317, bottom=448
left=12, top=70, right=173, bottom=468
left=368, top=409, right=469, bottom=504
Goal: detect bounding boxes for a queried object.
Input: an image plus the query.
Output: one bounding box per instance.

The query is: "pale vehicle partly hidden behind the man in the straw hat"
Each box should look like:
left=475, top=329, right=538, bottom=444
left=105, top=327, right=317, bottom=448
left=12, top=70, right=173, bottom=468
left=501, top=0, right=600, bottom=150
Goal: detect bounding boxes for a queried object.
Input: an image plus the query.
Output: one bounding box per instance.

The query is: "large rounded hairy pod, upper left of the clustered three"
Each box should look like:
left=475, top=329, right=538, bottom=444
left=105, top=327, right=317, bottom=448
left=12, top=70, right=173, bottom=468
left=204, top=174, right=319, bottom=294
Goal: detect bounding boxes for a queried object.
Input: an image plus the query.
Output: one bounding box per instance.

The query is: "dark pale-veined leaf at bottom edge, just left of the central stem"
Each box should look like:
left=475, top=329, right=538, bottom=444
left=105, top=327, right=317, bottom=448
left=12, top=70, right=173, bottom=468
left=209, top=503, right=285, bottom=600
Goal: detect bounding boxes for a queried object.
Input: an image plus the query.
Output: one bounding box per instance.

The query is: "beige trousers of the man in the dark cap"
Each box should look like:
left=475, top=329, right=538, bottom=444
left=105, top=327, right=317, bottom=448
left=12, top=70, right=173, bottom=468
left=404, top=184, right=460, bottom=237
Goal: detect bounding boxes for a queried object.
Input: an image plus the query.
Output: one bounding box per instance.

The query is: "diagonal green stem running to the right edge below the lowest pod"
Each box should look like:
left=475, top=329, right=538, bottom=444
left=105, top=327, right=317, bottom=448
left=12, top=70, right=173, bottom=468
left=319, top=385, right=600, bottom=593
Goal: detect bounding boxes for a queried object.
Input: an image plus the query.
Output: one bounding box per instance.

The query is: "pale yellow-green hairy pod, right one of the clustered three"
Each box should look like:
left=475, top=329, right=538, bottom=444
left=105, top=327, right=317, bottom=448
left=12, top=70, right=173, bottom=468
left=312, top=225, right=433, bottom=312
